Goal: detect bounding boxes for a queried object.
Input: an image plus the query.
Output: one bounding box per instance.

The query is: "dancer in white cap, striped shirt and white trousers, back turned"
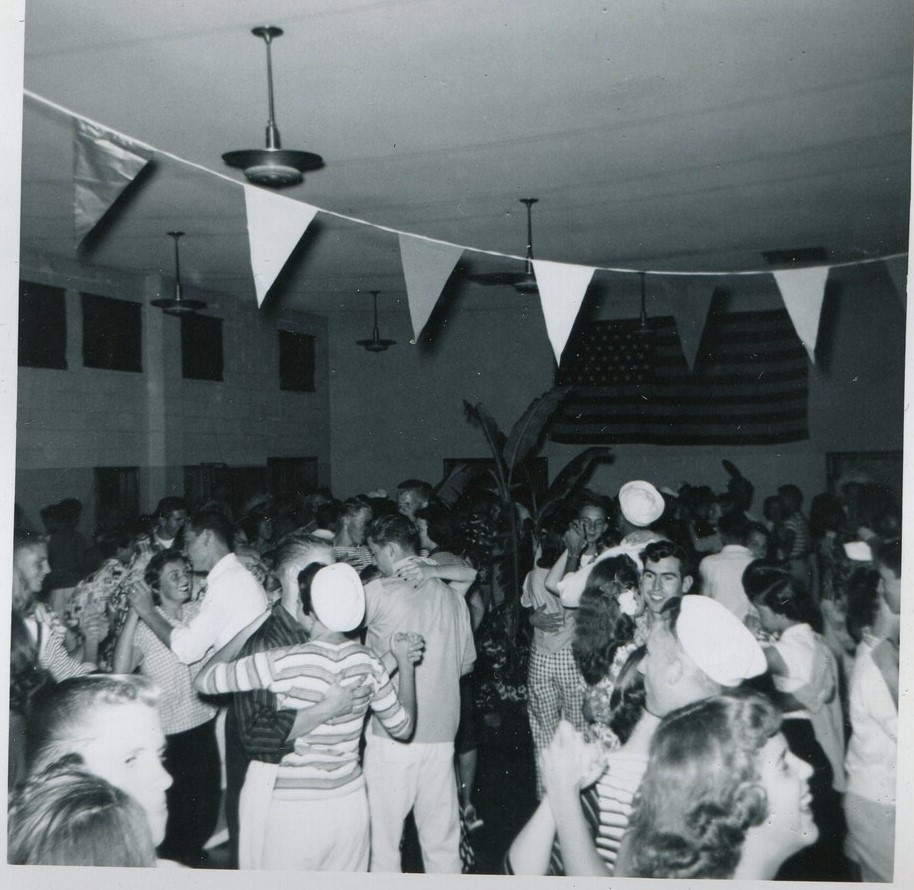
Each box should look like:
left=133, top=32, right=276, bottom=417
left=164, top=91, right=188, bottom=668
left=196, top=563, right=423, bottom=871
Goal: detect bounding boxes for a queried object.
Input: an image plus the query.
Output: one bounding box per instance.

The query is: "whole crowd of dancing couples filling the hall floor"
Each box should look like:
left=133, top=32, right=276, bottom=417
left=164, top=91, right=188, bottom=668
left=8, top=460, right=901, bottom=881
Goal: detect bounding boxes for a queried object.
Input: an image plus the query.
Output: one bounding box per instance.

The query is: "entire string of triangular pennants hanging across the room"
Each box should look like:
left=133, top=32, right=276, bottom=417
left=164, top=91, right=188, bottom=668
left=37, top=90, right=908, bottom=369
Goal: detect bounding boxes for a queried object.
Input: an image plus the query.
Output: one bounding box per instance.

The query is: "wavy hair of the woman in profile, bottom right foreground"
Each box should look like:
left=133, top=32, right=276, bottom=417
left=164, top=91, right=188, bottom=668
left=626, top=690, right=781, bottom=878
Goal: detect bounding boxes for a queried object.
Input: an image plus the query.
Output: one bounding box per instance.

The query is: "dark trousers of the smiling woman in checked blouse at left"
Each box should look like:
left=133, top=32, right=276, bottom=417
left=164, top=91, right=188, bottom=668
left=159, top=718, right=221, bottom=865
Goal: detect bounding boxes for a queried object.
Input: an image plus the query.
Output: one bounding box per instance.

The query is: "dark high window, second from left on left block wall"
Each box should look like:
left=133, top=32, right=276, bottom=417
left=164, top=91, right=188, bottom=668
left=80, top=294, right=143, bottom=372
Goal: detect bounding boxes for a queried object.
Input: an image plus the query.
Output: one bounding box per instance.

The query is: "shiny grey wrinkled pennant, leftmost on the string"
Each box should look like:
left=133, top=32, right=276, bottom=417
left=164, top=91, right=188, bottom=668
left=73, top=120, right=153, bottom=245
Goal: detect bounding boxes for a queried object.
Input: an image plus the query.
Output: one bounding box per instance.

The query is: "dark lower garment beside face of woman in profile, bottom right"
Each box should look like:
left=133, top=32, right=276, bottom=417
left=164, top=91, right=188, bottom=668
left=776, top=719, right=853, bottom=881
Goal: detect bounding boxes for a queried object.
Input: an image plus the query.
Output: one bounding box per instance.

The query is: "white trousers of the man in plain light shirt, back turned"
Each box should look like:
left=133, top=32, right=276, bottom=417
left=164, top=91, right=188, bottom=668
left=364, top=733, right=461, bottom=874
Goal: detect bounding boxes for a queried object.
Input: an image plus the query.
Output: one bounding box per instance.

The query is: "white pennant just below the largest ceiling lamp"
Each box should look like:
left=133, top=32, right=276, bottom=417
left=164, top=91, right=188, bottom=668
left=244, top=185, right=318, bottom=306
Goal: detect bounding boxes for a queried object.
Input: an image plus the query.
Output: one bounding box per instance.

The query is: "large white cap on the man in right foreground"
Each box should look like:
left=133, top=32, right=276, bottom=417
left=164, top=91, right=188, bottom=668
left=675, top=594, right=768, bottom=686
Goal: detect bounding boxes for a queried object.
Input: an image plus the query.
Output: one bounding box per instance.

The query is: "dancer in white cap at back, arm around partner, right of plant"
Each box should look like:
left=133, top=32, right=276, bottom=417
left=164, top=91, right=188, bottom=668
left=546, top=479, right=665, bottom=609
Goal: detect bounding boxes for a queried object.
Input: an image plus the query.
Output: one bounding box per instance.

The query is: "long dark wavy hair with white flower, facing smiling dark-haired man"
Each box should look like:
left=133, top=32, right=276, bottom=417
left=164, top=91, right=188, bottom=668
left=571, top=555, right=639, bottom=686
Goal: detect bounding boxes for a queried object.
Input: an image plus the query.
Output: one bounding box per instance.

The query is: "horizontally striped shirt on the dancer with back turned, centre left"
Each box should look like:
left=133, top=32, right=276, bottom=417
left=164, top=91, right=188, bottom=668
left=198, top=640, right=411, bottom=795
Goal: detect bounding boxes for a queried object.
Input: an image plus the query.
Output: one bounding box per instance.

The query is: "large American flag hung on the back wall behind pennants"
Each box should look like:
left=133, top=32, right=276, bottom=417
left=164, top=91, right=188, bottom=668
left=549, top=310, right=809, bottom=445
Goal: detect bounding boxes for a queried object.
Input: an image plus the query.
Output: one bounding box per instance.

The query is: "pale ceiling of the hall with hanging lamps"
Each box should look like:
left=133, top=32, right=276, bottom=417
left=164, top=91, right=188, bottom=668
left=21, top=0, right=914, bottom=313
